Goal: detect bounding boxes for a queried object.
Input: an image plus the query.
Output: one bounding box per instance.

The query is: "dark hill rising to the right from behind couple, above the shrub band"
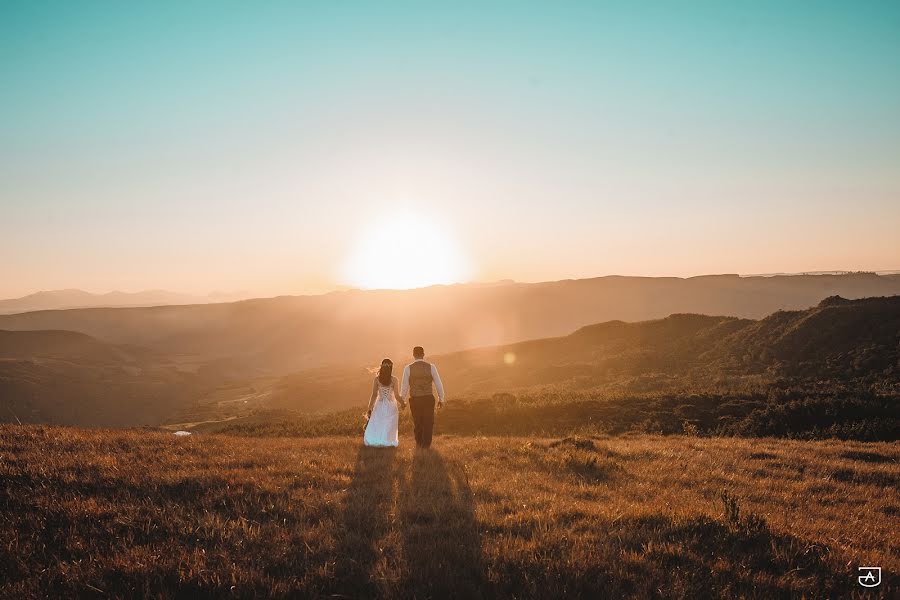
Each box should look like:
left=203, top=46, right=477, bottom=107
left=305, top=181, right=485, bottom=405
left=266, top=296, right=900, bottom=410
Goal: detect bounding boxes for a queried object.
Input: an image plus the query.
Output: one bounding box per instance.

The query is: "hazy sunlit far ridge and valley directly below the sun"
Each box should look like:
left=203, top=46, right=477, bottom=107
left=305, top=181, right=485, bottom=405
left=0, top=273, right=900, bottom=378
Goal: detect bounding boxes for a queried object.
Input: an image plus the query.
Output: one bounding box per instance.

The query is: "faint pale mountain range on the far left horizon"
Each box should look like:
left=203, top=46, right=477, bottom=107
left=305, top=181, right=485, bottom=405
left=0, top=290, right=247, bottom=314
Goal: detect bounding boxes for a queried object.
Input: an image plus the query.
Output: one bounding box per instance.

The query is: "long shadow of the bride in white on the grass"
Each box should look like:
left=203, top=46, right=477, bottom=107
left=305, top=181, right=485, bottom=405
left=333, top=446, right=397, bottom=598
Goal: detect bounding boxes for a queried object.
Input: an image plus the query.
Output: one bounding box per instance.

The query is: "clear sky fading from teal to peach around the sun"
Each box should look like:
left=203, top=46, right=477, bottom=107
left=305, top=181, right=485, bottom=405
left=0, top=0, right=900, bottom=297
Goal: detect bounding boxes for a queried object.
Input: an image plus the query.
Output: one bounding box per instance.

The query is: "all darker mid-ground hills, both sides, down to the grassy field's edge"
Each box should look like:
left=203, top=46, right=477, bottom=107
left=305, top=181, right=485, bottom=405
left=0, top=297, right=900, bottom=432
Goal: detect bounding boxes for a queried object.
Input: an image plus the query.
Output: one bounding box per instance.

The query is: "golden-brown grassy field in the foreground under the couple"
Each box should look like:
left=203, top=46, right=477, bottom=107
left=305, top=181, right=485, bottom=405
left=0, top=426, right=900, bottom=598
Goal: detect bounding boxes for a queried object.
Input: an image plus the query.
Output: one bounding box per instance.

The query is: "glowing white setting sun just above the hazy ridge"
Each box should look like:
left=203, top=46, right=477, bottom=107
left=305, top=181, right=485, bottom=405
left=343, top=214, right=469, bottom=290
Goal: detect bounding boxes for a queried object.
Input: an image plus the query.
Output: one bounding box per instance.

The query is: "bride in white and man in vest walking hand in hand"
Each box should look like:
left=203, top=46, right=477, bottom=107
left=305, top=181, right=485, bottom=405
left=363, top=346, right=444, bottom=448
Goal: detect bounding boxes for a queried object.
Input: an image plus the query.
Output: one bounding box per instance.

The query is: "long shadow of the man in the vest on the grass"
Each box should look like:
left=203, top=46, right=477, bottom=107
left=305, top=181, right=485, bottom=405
left=400, top=449, right=489, bottom=598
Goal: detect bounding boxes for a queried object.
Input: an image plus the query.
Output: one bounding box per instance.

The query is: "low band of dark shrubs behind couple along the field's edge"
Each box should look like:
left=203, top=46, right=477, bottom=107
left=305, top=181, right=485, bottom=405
left=200, top=388, right=900, bottom=441
